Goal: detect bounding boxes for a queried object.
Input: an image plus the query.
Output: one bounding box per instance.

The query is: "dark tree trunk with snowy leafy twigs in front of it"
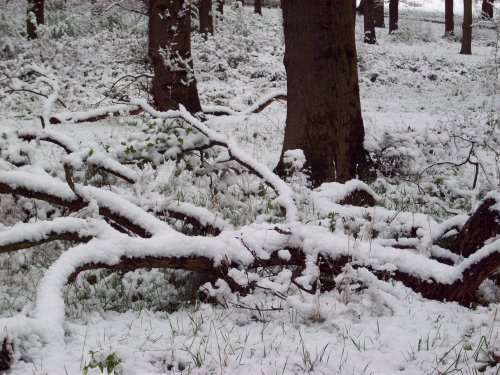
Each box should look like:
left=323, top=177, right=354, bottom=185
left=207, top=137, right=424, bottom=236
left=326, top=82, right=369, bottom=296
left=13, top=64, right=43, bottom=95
left=149, top=0, right=201, bottom=113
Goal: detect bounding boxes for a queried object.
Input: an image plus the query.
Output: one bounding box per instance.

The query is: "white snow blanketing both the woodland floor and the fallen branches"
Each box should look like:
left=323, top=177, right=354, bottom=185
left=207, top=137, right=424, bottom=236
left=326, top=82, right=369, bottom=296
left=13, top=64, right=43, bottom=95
left=0, top=0, right=500, bottom=374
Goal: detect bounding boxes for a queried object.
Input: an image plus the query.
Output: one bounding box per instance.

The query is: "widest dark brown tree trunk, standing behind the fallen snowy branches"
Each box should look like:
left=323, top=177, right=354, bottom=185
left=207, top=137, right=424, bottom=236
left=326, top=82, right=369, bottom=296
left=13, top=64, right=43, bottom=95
left=276, top=0, right=369, bottom=186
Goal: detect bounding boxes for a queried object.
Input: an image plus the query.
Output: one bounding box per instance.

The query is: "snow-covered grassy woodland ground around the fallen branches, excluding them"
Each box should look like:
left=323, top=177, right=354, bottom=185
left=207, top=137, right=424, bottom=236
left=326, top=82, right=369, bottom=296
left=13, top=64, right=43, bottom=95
left=0, top=0, right=500, bottom=374
